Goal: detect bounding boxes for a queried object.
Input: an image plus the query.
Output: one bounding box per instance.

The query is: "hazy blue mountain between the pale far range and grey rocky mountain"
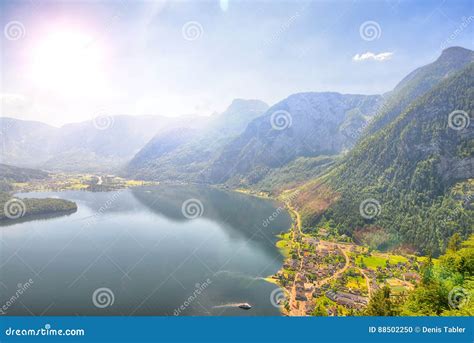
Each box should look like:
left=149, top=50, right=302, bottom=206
left=126, top=99, right=268, bottom=182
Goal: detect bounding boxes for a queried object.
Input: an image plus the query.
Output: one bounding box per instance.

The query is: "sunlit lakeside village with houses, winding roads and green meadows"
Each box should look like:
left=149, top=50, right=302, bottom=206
left=269, top=211, right=423, bottom=316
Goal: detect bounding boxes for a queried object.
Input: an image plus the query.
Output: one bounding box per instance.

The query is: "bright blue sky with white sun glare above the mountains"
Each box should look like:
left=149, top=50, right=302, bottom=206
left=0, top=0, right=474, bottom=126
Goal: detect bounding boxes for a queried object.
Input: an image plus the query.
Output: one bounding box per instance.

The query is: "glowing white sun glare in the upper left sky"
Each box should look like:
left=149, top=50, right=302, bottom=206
left=31, top=31, right=103, bottom=94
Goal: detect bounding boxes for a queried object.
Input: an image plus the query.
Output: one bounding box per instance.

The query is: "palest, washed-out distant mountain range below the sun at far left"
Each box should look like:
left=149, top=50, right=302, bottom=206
left=0, top=115, right=206, bottom=172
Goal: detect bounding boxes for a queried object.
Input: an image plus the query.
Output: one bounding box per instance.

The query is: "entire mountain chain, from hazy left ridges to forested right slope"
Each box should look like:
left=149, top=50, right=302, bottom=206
left=0, top=47, right=474, bottom=252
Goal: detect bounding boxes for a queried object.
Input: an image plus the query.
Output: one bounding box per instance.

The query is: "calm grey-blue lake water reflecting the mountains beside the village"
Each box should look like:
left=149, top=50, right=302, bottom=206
left=0, top=185, right=291, bottom=316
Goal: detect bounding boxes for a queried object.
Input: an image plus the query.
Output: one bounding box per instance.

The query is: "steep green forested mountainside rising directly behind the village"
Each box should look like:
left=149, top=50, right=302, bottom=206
left=295, top=61, right=474, bottom=254
